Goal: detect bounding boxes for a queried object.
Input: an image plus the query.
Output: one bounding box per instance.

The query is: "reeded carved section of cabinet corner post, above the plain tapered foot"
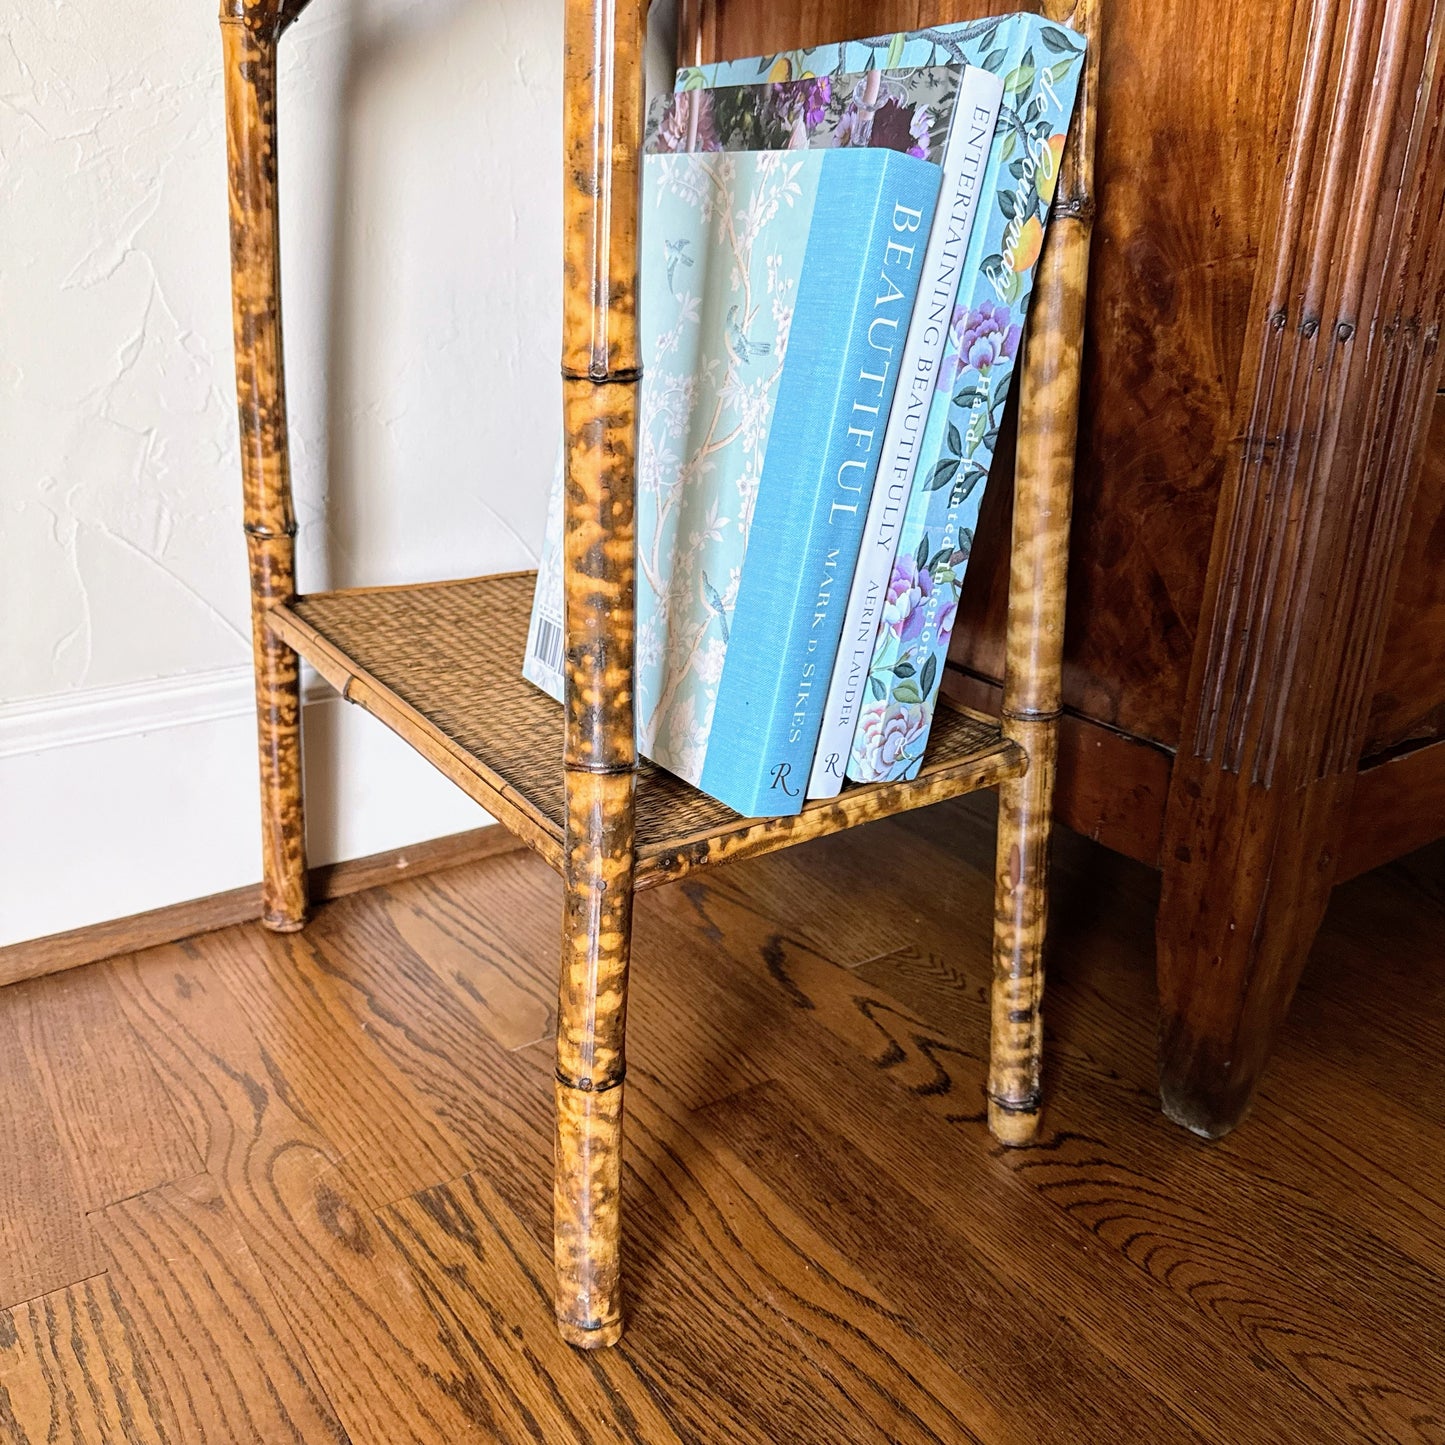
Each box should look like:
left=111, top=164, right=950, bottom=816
left=1186, top=0, right=1445, bottom=786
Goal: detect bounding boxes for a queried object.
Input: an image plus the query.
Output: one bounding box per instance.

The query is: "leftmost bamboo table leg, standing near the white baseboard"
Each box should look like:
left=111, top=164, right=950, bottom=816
left=221, top=0, right=306, bottom=932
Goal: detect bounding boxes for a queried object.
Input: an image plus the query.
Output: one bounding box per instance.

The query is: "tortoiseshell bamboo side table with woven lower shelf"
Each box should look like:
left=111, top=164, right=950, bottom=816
left=221, top=0, right=1097, bottom=1348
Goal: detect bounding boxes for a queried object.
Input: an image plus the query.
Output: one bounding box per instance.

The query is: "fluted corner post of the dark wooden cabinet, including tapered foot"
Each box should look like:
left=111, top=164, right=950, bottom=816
left=1159, top=0, right=1445, bottom=1136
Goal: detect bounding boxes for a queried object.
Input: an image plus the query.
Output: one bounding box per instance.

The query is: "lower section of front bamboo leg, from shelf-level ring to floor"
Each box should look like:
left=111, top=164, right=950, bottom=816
left=553, top=770, right=634, bottom=1350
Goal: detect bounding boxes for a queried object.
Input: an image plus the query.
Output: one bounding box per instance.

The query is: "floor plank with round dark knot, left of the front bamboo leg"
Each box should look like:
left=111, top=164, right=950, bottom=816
left=105, top=941, right=494, bottom=1445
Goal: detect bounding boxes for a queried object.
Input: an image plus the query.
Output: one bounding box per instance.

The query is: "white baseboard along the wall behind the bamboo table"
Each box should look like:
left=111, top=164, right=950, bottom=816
left=0, top=668, right=490, bottom=946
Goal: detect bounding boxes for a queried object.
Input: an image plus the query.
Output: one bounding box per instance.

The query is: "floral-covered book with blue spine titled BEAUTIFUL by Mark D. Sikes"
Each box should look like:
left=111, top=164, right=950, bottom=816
left=523, top=147, right=941, bottom=816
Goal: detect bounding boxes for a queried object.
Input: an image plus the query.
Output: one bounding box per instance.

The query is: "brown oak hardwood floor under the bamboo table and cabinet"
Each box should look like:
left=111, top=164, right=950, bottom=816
left=0, top=799, right=1445, bottom=1445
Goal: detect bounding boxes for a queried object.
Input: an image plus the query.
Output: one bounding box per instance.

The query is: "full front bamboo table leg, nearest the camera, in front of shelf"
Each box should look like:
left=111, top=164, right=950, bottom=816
left=555, top=0, right=643, bottom=1348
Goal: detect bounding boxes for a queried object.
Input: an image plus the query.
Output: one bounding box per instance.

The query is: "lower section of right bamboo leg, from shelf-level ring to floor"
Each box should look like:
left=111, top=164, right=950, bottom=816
left=988, top=721, right=1058, bottom=1146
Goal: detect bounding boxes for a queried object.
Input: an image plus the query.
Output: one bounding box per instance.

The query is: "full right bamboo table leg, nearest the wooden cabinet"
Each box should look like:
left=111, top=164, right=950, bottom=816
left=988, top=0, right=1098, bottom=1144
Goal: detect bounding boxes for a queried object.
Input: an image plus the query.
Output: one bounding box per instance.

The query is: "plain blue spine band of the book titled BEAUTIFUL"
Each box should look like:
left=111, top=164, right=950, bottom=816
left=701, top=150, right=941, bottom=816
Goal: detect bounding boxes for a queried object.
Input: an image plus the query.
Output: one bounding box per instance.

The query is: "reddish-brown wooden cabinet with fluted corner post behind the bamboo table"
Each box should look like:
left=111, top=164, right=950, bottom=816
left=682, top=0, right=1445, bottom=1134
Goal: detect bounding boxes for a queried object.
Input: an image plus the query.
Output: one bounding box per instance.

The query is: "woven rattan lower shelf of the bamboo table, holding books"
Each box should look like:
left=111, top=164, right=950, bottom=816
left=267, top=572, right=1026, bottom=889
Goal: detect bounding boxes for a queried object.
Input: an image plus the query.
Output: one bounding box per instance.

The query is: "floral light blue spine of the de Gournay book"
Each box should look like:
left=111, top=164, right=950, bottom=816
left=847, top=16, right=1084, bottom=783
